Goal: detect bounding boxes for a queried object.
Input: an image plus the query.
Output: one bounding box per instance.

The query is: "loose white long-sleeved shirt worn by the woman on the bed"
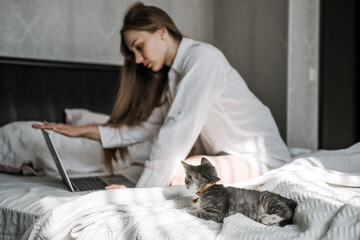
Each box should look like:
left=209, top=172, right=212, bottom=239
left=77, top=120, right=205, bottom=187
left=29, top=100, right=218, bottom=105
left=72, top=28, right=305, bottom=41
left=99, top=38, right=290, bottom=187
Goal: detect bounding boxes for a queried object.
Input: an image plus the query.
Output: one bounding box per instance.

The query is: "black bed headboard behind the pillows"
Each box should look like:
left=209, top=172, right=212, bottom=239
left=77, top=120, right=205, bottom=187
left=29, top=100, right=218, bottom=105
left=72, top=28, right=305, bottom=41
left=0, top=57, right=121, bottom=126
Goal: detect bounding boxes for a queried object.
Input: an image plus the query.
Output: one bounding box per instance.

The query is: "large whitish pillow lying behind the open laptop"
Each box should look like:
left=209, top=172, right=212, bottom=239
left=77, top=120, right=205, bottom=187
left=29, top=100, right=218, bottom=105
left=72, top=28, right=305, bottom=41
left=0, top=121, right=127, bottom=175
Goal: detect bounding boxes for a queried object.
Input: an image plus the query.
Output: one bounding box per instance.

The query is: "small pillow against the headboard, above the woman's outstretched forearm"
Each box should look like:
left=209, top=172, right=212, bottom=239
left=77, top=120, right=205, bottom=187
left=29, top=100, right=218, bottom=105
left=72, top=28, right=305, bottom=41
left=64, top=108, right=109, bottom=126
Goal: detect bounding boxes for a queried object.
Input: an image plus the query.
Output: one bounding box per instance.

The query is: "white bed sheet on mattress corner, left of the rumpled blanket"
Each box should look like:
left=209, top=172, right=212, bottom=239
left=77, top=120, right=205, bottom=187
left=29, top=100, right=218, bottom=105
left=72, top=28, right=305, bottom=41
left=0, top=173, right=85, bottom=240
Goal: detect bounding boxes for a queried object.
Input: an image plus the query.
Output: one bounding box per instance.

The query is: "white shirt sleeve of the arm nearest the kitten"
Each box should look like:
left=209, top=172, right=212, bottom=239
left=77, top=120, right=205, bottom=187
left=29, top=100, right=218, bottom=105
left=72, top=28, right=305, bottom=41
left=136, top=47, right=224, bottom=187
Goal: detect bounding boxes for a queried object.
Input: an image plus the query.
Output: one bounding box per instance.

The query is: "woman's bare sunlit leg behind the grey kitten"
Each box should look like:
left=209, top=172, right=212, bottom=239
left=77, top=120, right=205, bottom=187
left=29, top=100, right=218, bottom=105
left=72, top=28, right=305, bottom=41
left=171, top=155, right=261, bottom=185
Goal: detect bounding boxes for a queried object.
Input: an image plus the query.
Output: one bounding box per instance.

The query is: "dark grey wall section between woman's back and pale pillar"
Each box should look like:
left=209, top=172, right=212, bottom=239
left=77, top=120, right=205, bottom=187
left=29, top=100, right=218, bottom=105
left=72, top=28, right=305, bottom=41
left=214, top=0, right=289, bottom=141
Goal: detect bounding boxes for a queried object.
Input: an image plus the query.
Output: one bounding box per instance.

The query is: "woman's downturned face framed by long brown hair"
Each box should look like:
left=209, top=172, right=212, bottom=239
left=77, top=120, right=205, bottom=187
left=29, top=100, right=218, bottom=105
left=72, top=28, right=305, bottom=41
left=124, top=29, right=170, bottom=72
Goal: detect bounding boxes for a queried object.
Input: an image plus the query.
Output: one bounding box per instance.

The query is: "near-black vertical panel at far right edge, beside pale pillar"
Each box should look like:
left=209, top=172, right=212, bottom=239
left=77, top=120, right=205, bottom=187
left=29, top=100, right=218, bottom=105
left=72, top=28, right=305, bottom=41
left=320, top=0, right=360, bottom=149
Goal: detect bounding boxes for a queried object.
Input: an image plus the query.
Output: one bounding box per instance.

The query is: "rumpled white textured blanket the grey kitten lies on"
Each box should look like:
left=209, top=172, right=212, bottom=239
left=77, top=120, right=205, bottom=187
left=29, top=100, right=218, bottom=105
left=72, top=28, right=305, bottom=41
left=24, top=143, right=360, bottom=240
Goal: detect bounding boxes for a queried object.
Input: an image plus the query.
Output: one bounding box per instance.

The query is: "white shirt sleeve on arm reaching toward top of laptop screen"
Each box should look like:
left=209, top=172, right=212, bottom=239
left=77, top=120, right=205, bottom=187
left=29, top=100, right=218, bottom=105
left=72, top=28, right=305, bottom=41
left=98, top=106, right=164, bottom=148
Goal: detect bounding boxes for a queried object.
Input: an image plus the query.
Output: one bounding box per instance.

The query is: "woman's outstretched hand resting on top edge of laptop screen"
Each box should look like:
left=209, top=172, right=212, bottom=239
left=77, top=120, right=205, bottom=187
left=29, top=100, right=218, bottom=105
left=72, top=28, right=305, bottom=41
left=32, top=121, right=100, bottom=140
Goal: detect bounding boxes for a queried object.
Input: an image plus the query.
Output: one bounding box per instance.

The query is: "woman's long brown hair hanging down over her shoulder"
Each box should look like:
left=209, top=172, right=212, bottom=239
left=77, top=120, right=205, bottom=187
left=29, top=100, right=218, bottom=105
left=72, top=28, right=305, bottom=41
left=104, top=2, right=183, bottom=173
